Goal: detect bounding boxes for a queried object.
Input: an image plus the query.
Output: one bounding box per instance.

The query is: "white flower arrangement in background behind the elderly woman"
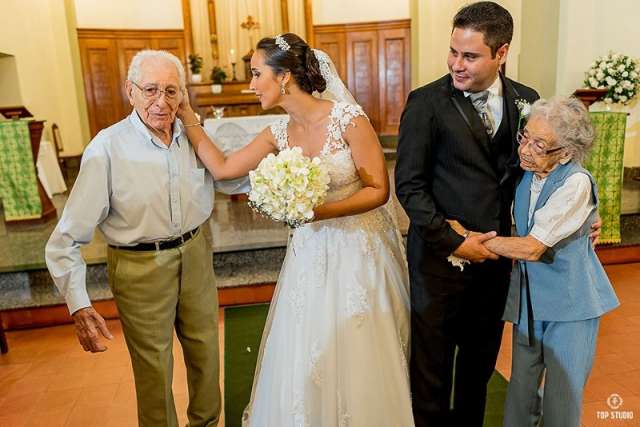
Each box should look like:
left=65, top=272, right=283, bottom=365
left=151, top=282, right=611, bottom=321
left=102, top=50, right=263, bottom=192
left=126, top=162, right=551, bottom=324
left=584, top=52, right=640, bottom=105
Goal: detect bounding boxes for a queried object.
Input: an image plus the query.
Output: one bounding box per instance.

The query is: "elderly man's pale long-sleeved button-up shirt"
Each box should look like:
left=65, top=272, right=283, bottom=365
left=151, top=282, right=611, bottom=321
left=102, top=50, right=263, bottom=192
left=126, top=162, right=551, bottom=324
left=45, top=110, right=249, bottom=313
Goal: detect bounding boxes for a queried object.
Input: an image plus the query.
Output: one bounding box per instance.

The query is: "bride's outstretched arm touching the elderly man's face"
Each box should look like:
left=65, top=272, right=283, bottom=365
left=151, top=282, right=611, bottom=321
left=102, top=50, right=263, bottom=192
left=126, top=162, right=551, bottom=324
left=178, top=102, right=276, bottom=180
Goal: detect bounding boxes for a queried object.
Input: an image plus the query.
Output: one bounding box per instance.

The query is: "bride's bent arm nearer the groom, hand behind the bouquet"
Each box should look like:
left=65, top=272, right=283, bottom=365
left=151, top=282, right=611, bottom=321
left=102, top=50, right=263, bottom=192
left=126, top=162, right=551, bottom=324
left=314, top=116, right=389, bottom=220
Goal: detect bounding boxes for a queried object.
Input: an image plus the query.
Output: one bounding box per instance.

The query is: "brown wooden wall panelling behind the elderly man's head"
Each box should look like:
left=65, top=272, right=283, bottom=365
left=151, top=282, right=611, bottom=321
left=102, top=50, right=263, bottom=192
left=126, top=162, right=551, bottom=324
left=78, top=29, right=186, bottom=137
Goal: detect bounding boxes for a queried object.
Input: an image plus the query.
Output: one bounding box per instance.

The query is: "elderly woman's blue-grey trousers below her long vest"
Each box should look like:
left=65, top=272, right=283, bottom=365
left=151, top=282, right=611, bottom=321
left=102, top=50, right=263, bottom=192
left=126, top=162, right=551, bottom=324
left=504, top=301, right=600, bottom=427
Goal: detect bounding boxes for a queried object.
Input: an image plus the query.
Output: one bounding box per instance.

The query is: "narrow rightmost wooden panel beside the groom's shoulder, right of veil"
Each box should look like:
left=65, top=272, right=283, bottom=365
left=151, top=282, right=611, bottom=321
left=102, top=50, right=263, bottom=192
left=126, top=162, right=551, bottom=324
left=378, top=29, right=411, bottom=134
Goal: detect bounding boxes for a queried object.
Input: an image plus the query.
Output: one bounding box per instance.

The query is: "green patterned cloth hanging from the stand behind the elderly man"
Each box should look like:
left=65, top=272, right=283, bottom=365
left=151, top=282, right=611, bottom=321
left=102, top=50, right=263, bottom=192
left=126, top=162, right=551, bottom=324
left=0, top=120, right=42, bottom=221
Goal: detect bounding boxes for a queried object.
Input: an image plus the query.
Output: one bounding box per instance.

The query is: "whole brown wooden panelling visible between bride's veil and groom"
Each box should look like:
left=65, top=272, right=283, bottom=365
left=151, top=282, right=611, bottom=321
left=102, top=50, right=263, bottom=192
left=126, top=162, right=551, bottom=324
left=314, top=19, right=411, bottom=134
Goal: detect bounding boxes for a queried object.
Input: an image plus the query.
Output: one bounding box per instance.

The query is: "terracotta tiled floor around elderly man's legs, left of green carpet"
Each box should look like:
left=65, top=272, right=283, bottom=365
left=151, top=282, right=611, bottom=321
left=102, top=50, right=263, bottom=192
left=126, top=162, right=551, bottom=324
left=0, top=311, right=224, bottom=427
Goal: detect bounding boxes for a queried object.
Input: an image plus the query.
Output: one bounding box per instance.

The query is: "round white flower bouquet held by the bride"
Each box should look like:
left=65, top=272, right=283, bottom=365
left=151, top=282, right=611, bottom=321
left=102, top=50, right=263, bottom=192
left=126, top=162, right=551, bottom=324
left=249, top=147, right=329, bottom=228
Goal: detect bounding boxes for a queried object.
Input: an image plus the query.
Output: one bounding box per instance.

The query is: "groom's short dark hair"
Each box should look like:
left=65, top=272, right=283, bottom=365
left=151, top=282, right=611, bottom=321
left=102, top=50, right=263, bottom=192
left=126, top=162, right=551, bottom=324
left=453, top=1, right=513, bottom=58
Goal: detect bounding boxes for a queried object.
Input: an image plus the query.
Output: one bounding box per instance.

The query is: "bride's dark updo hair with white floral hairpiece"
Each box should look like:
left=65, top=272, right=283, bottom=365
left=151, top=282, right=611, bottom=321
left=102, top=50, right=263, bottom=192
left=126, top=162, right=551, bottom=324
left=256, top=33, right=327, bottom=93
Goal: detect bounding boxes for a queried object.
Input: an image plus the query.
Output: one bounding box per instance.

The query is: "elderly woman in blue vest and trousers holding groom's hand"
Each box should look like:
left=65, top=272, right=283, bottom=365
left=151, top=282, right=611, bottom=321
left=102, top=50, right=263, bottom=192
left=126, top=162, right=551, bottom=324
left=456, top=97, right=619, bottom=427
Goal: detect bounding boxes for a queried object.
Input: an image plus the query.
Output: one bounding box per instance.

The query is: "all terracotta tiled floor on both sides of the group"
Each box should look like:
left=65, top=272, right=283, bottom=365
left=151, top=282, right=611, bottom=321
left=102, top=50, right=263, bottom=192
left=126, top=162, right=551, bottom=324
left=0, top=264, right=640, bottom=427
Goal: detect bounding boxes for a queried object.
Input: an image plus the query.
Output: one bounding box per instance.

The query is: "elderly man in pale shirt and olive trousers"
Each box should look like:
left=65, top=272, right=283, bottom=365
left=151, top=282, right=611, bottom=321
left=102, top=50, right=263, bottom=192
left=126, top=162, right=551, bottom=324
left=46, top=50, right=247, bottom=427
